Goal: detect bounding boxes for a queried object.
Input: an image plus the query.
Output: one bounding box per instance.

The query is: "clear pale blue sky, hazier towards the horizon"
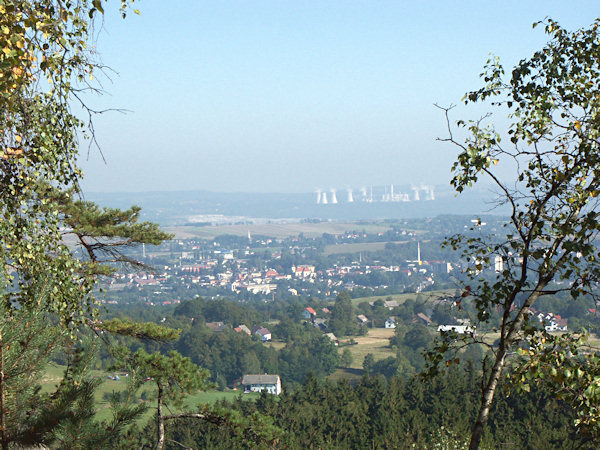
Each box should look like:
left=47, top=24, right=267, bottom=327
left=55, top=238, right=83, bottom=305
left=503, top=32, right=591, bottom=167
left=81, top=0, right=600, bottom=192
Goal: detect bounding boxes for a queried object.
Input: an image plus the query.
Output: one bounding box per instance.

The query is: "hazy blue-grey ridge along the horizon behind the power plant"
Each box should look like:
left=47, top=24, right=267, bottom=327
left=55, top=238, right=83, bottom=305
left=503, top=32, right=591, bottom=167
left=86, top=187, right=506, bottom=225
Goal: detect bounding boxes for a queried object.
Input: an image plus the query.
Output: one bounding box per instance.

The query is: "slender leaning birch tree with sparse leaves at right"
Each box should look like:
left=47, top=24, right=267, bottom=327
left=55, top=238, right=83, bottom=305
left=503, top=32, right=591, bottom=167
left=429, top=15, right=600, bottom=448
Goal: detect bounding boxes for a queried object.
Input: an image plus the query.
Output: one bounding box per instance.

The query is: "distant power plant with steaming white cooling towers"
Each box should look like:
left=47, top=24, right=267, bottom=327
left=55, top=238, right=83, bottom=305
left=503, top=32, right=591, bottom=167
left=316, top=184, right=435, bottom=205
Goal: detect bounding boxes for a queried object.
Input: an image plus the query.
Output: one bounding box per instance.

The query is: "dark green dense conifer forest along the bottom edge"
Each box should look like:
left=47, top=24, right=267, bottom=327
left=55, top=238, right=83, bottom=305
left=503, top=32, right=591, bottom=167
left=164, top=364, right=594, bottom=449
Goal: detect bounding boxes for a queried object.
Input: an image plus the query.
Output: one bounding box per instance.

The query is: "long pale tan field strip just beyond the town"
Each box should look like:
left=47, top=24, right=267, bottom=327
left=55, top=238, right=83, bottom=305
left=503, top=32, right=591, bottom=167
left=164, top=222, right=390, bottom=239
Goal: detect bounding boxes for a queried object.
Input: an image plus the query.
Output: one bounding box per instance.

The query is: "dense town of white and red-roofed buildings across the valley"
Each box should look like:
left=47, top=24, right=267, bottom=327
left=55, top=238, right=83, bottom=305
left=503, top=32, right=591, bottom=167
left=107, top=236, right=452, bottom=303
